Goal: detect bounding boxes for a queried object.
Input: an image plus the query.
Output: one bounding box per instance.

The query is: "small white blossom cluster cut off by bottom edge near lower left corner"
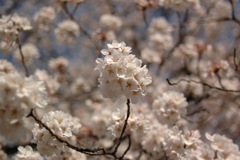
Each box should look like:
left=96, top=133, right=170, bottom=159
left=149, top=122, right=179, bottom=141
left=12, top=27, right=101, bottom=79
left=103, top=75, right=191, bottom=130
left=14, top=146, right=44, bottom=160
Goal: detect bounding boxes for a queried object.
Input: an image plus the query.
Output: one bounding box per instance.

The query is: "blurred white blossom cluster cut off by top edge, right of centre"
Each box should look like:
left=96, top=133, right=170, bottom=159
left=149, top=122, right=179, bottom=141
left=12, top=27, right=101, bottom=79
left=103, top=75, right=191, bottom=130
left=159, top=0, right=199, bottom=11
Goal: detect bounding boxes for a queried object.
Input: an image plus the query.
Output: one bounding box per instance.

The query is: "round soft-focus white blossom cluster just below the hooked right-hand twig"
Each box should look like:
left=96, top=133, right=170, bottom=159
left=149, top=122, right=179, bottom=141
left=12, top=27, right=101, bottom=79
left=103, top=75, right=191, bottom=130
left=153, top=91, right=188, bottom=125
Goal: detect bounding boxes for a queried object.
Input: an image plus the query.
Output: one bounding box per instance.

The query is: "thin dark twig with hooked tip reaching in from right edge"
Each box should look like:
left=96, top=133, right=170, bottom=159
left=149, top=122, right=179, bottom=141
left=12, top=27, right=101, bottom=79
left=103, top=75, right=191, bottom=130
left=166, top=79, right=240, bottom=93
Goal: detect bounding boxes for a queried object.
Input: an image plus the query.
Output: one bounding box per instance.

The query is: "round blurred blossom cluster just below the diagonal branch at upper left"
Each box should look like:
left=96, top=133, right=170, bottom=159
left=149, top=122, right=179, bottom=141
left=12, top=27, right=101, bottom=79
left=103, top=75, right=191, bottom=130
left=54, top=20, right=80, bottom=44
